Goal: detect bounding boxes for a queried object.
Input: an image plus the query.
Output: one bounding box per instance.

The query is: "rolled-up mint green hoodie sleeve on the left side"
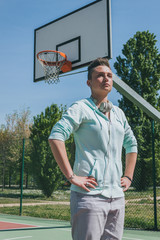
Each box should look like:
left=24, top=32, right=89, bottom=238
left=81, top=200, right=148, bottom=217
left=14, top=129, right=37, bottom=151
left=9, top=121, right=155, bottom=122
left=49, top=103, right=83, bottom=141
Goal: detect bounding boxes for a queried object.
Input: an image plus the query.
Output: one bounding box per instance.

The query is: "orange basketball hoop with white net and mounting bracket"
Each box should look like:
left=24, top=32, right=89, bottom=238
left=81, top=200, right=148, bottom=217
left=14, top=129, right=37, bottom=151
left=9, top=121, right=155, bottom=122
left=37, top=50, right=72, bottom=84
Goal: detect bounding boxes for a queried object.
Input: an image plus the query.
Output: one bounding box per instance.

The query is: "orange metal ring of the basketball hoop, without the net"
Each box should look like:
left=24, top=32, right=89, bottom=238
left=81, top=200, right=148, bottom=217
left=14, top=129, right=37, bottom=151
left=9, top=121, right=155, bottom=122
left=37, top=50, right=67, bottom=66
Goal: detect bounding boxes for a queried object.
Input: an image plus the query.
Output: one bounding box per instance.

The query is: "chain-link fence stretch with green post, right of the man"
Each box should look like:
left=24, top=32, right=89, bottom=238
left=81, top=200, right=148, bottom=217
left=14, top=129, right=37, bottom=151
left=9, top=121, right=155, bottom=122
left=123, top=118, right=160, bottom=230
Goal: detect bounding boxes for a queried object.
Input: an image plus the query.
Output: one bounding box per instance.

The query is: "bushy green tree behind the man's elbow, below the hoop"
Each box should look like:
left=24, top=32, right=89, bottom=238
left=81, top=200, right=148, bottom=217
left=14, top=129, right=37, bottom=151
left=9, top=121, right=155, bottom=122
left=31, top=104, right=73, bottom=197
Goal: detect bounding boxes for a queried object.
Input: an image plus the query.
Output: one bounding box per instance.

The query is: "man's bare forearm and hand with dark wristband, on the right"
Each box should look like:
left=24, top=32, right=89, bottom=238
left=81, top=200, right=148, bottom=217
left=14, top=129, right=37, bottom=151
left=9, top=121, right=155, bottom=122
left=121, top=152, right=137, bottom=192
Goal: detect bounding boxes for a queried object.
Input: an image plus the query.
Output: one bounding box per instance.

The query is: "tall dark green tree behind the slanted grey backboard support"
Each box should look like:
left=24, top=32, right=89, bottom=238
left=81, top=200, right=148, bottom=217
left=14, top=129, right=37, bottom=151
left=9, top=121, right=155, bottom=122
left=114, top=31, right=160, bottom=190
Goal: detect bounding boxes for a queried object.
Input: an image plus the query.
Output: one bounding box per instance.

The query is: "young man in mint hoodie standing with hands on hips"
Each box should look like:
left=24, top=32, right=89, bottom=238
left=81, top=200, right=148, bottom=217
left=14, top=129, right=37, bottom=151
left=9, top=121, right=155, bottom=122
left=49, top=58, right=137, bottom=240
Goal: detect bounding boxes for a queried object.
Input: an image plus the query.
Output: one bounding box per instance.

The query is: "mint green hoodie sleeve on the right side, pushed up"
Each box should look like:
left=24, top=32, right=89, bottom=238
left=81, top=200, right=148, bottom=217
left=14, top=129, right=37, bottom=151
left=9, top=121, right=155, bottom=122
left=123, top=110, right=137, bottom=154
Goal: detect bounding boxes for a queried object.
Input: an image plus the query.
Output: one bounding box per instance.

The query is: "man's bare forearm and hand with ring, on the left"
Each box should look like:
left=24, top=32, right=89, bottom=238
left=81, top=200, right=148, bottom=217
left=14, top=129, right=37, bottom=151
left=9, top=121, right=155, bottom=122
left=49, top=139, right=97, bottom=192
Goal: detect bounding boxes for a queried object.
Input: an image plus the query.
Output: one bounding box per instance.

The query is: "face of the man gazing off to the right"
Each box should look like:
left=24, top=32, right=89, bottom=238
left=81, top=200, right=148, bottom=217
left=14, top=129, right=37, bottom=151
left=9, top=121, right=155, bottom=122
left=87, top=65, right=113, bottom=95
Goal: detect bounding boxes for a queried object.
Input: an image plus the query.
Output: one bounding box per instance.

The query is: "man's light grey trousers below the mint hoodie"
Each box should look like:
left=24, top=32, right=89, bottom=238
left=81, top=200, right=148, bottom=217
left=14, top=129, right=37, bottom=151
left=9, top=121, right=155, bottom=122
left=71, top=191, right=125, bottom=240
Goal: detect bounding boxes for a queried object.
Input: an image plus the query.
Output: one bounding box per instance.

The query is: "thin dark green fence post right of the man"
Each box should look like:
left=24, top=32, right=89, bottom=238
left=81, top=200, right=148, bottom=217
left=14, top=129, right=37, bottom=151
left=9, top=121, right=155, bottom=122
left=151, top=119, right=158, bottom=231
